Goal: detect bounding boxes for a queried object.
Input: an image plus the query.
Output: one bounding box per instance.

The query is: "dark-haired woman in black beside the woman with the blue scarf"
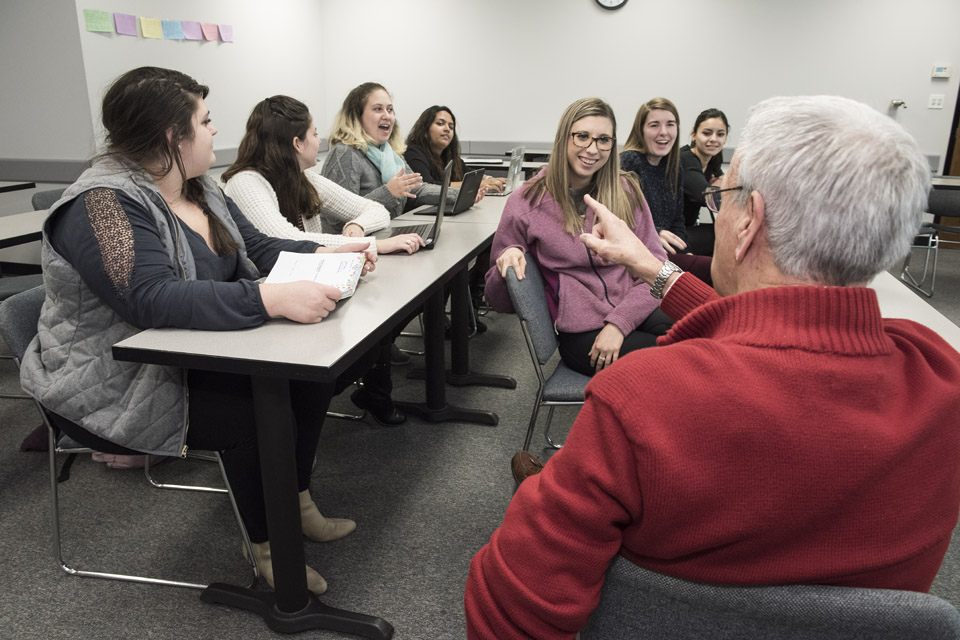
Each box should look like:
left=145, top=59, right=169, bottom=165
left=403, top=105, right=507, bottom=192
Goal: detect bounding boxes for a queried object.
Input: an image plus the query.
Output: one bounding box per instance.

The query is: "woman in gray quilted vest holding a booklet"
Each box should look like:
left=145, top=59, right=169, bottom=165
left=21, top=67, right=375, bottom=593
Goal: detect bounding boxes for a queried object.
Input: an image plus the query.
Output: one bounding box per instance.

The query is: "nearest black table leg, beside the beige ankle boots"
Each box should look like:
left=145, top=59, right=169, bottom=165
left=200, top=378, right=396, bottom=640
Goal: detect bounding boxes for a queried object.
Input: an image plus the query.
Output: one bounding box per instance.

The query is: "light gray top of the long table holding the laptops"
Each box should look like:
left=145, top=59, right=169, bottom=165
left=114, top=224, right=496, bottom=379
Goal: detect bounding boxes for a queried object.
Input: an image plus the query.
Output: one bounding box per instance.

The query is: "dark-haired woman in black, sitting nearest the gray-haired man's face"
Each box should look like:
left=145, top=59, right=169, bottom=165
left=680, top=109, right=730, bottom=256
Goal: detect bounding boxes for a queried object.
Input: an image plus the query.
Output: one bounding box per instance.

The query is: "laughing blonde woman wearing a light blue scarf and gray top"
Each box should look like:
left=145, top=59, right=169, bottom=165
left=320, top=82, right=459, bottom=224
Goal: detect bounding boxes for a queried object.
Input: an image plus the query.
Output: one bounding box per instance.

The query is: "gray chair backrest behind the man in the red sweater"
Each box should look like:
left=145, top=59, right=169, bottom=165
left=580, top=556, right=960, bottom=640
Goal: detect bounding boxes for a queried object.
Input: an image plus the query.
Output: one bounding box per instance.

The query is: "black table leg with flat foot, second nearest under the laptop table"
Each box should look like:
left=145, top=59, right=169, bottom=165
left=395, top=284, right=500, bottom=425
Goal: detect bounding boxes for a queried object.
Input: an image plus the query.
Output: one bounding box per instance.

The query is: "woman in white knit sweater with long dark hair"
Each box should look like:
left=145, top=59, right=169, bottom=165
left=222, top=96, right=423, bottom=253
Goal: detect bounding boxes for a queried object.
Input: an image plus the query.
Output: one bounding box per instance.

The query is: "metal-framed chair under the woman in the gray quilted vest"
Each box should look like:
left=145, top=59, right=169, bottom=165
left=0, top=287, right=258, bottom=589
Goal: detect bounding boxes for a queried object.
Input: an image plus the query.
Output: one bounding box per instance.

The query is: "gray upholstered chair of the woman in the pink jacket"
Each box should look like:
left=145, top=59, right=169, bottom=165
left=506, top=253, right=590, bottom=451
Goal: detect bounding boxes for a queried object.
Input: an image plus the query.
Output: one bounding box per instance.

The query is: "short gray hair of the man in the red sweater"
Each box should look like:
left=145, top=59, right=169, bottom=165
left=731, top=96, right=930, bottom=286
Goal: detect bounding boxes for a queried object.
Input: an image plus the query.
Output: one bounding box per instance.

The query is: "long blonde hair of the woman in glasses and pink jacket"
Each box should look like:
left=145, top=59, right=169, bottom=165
left=524, top=98, right=643, bottom=233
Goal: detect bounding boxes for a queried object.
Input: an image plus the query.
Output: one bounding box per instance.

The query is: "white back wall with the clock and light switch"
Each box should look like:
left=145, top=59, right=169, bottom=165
left=316, top=0, right=960, bottom=170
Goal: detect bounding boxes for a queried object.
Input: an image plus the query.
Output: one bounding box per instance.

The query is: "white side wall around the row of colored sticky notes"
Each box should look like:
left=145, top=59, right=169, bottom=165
left=74, top=0, right=324, bottom=154
